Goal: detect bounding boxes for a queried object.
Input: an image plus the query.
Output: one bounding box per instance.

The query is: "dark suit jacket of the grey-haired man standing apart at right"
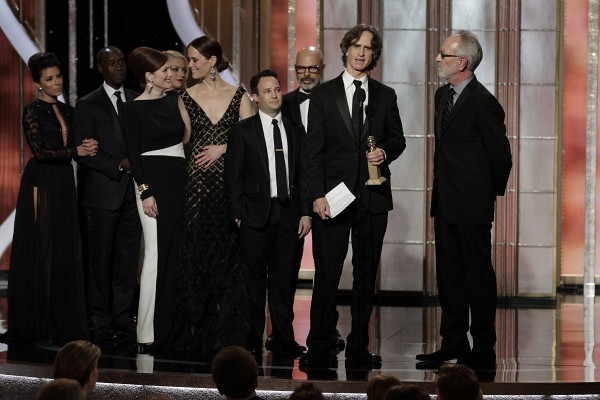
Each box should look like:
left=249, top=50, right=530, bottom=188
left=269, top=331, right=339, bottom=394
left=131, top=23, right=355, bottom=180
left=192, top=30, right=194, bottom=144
left=431, top=78, right=512, bottom=225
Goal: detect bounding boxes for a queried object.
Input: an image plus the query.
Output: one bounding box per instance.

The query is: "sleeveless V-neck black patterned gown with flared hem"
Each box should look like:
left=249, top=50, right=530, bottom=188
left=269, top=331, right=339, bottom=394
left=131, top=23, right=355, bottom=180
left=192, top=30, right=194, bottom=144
left=173, top=87, right=249, bottom=359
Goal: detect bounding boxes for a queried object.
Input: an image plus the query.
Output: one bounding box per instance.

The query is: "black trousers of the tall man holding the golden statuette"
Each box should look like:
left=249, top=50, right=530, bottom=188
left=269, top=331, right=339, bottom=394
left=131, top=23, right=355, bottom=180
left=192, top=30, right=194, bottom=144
left=307, top=202, right=388, bottom=353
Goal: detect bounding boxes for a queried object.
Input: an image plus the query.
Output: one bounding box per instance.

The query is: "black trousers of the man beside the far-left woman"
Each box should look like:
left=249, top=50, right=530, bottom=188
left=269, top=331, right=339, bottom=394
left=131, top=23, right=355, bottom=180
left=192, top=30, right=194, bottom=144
left=85, top=184, right=142, bottom=329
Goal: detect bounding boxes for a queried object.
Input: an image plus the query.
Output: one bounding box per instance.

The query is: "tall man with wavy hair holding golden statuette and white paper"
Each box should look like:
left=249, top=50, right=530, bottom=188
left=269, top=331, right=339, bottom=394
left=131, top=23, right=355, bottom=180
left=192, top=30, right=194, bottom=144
left=300, top=24, right=406, bottom=368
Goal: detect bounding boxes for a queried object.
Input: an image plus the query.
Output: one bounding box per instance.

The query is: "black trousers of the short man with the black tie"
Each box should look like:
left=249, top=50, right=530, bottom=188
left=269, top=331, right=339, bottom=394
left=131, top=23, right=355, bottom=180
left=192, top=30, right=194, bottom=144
left=240, top=199, right=300, bottom=346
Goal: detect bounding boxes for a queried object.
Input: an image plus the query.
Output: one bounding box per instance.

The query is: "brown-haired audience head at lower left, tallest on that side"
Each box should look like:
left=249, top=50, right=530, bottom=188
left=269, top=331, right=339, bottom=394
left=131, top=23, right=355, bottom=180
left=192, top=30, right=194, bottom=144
left=53, top=340, right=100, bottom=394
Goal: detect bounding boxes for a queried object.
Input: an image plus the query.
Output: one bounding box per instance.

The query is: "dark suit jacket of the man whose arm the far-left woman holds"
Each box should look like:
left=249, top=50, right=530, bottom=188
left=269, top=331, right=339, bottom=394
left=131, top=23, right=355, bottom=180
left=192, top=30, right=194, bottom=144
left=74, top=86, right=137, bottom=210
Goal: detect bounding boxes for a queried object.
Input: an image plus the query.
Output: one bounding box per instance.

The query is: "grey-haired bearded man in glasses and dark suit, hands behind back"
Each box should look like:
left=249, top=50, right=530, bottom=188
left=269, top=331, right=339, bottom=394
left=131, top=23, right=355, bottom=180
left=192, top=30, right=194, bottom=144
left=417, top=31, right=512, bottom=370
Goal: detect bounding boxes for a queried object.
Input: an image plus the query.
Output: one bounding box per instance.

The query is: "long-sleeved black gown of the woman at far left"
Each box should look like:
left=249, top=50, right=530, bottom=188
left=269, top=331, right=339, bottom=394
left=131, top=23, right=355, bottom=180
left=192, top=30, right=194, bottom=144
left=2, top=100, right=87, bottom=345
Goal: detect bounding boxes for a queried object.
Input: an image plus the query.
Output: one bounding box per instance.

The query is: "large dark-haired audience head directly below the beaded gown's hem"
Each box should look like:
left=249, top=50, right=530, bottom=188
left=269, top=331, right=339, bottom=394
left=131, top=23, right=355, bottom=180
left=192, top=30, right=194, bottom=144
left=212, top=346, right=258, bottom=399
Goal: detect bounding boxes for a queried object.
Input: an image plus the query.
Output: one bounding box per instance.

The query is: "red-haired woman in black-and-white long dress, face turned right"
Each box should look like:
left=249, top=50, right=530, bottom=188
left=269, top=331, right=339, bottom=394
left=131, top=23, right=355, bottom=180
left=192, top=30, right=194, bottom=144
left=121, top=46, right=190, bottom=350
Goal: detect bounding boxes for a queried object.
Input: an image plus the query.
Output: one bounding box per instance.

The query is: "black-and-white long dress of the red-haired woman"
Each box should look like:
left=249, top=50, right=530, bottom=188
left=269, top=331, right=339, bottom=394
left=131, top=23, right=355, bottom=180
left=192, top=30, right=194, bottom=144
left=121, top=96, right=185, bottom=348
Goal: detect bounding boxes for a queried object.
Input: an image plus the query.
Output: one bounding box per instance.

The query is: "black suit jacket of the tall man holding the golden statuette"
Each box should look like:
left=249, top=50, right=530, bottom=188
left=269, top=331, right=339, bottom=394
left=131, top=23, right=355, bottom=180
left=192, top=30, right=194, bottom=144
left=302, top=74, right=406, bottom=213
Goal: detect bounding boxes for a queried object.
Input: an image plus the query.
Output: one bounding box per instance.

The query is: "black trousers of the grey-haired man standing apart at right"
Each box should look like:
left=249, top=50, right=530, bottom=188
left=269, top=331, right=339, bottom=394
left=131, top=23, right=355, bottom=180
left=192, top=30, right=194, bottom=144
left=434, top=212, right=496, bottom=354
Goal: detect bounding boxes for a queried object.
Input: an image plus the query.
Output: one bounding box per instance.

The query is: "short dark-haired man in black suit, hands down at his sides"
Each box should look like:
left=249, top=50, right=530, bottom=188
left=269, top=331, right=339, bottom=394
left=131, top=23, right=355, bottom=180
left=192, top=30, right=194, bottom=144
left=225, top=70, right=312, bottom=357
